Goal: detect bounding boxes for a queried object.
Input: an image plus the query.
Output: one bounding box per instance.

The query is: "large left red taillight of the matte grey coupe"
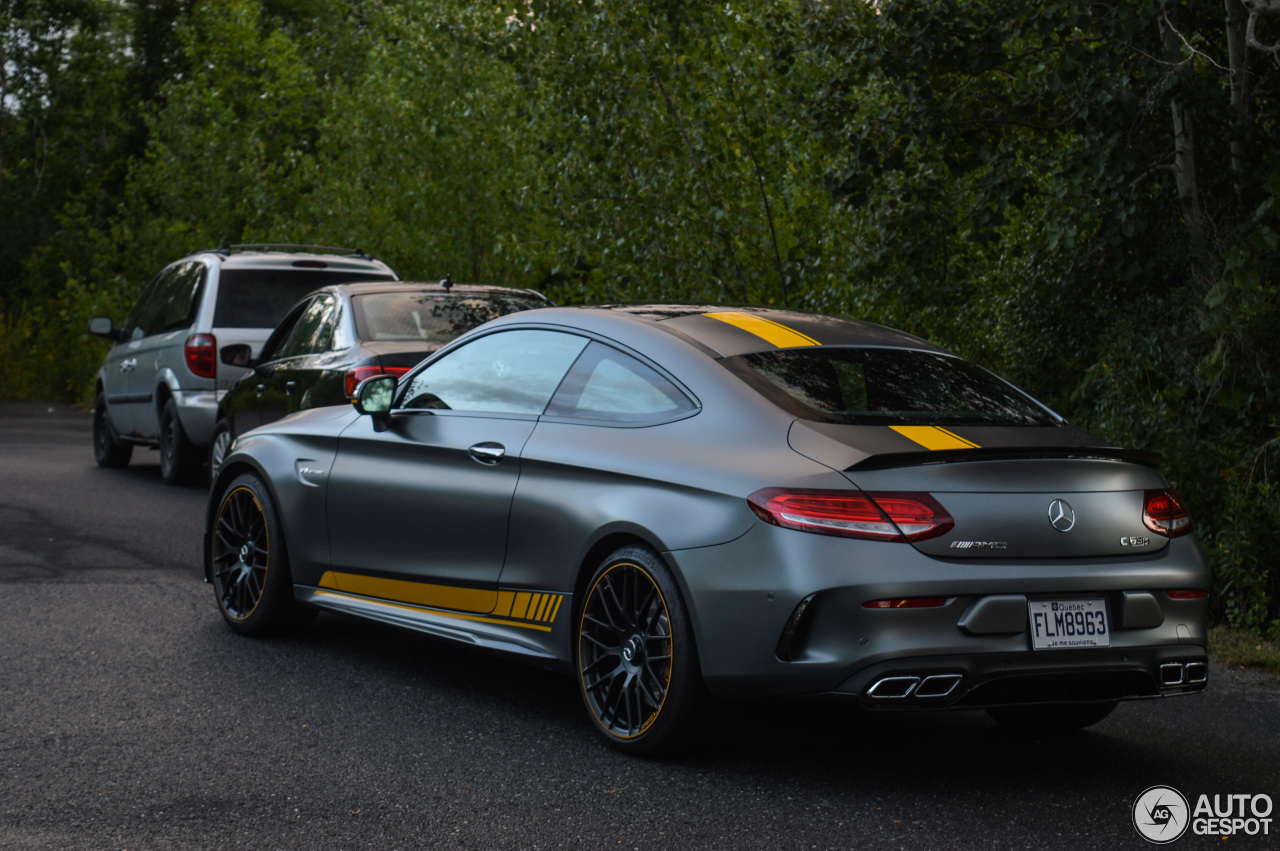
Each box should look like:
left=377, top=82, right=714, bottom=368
left=748, top=488, right=955, bottom=541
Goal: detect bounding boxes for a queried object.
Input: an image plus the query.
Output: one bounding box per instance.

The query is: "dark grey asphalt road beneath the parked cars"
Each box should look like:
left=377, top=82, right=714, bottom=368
left=0, top=406, right=1280, bottom=851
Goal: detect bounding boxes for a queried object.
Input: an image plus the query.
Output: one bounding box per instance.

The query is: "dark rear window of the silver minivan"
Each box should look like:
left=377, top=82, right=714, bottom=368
left=214, top=269, right=396, bottom=328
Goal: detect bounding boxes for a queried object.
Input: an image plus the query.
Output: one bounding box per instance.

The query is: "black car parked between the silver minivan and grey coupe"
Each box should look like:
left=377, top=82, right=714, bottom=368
left=209, top=279, right=550, bottom=479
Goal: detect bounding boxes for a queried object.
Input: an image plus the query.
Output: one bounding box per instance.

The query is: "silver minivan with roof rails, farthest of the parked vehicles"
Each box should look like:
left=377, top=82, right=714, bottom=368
left=88, top=244, right=398, bottom=484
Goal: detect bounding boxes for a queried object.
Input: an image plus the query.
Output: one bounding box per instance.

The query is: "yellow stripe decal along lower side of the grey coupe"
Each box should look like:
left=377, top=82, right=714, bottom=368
left=320, top=571, right=564, bottom=628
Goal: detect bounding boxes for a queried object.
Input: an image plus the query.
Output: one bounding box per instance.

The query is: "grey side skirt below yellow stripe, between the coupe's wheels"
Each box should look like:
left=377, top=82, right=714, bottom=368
left=293, top=585, right=557, bottom=662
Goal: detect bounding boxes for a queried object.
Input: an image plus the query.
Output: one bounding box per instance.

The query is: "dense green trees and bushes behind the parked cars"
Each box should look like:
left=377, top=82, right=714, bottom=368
left=0, top=0, right=1280, bottom=640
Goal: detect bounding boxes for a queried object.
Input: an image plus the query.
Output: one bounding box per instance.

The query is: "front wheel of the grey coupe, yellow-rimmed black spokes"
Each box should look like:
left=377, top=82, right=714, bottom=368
left=209, top=473, right=316, bottom=636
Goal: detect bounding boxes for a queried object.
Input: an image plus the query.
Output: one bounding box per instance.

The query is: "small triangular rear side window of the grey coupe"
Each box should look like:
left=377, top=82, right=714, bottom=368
left=547, top=343, right=695, bottom=422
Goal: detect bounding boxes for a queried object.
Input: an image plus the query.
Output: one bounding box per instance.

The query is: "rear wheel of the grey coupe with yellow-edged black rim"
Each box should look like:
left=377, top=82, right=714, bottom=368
left=573, top=546, right=709, bottom=755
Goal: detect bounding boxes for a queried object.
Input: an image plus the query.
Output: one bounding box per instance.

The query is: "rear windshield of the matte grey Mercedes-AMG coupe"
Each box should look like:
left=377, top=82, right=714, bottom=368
left=723, top=346, right=1057, bottom=426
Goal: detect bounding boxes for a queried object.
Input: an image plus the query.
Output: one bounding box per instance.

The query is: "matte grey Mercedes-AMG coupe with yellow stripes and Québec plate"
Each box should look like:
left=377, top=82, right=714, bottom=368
left=205, top=306, right=1210, bottom=752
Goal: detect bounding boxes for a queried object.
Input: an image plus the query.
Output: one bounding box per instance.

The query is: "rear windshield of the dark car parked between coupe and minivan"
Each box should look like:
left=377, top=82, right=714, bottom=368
left=351, top=292, right=547, bottom=343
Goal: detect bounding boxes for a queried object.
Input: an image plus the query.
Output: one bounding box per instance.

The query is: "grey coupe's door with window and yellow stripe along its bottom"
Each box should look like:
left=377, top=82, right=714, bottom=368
left=328, top=329, right=588, bottom=614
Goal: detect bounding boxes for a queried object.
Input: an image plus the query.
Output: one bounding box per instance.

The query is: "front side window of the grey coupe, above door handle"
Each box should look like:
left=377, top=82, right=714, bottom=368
left=402, top=330, right=588, bottom=416
